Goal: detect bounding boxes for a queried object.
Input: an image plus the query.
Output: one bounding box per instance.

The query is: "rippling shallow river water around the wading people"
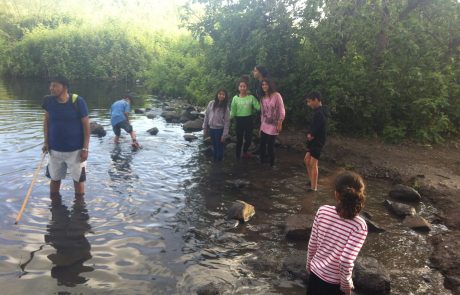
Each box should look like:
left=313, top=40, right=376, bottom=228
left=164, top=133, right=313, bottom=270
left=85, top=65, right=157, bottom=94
left=0, top=80, right=450, bottom=295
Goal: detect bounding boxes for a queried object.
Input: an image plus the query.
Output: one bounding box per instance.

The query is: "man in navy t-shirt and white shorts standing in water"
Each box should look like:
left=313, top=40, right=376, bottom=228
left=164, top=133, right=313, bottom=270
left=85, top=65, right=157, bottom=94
left=42, top=76, right=90, bottom=199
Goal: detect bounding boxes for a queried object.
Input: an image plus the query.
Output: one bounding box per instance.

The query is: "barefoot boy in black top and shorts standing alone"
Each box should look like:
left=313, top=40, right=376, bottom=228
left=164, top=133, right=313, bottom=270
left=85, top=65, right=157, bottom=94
left=304, top=91, right=326, bottom=191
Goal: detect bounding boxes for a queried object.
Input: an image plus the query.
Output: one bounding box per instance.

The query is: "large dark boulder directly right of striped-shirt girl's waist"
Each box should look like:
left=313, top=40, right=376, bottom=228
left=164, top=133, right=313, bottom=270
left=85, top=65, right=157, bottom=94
left=353, top=257, right=391, bottom=295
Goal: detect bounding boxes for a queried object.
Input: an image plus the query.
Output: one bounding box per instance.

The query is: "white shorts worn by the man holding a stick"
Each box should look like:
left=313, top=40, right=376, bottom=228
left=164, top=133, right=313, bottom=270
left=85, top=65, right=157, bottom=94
left=46, top=150, right=86, bottom=182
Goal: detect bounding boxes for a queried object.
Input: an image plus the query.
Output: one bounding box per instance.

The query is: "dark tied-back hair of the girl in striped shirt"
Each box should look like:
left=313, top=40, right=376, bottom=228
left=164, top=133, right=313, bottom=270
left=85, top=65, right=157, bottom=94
left=335, top=172, right=366, bottom=219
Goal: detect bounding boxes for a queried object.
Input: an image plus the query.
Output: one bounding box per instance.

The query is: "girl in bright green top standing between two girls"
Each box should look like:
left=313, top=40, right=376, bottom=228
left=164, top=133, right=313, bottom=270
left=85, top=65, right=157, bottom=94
left=230, top=77, right=260, bottom=159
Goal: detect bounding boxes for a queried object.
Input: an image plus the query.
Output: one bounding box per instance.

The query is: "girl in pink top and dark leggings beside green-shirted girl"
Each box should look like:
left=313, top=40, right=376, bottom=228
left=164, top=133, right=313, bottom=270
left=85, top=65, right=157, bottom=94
left=260, top=78, right=286, bottom=166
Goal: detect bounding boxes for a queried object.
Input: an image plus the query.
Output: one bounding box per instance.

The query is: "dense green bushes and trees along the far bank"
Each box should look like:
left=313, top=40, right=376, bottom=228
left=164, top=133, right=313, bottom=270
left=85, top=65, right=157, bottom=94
left=0, top=0, right=460, bottom=142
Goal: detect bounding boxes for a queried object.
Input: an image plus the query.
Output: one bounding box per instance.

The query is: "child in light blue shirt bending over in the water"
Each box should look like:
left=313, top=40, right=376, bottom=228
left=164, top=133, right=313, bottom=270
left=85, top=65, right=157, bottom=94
left=110, top=94, right=140, bottom=148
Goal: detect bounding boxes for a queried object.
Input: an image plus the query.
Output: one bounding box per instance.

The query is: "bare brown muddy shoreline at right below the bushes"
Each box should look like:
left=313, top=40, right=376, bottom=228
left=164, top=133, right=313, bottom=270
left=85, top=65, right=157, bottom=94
left=279, top=130, right=460, bottom=294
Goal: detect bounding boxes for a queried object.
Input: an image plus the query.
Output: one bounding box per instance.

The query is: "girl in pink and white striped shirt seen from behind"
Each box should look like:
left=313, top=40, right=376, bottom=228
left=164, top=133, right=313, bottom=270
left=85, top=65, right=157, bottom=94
left=306, top=172, right=367, bottom=295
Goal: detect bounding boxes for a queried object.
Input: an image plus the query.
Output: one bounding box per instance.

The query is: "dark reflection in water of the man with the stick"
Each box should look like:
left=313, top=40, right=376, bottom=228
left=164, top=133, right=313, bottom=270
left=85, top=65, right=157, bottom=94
left=45, top=197, right=94, bottom=287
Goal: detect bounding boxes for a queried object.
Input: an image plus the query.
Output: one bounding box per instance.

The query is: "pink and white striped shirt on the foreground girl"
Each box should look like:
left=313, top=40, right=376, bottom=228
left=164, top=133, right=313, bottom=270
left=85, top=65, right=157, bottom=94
left=306, top=205, right=367, bottom=291
